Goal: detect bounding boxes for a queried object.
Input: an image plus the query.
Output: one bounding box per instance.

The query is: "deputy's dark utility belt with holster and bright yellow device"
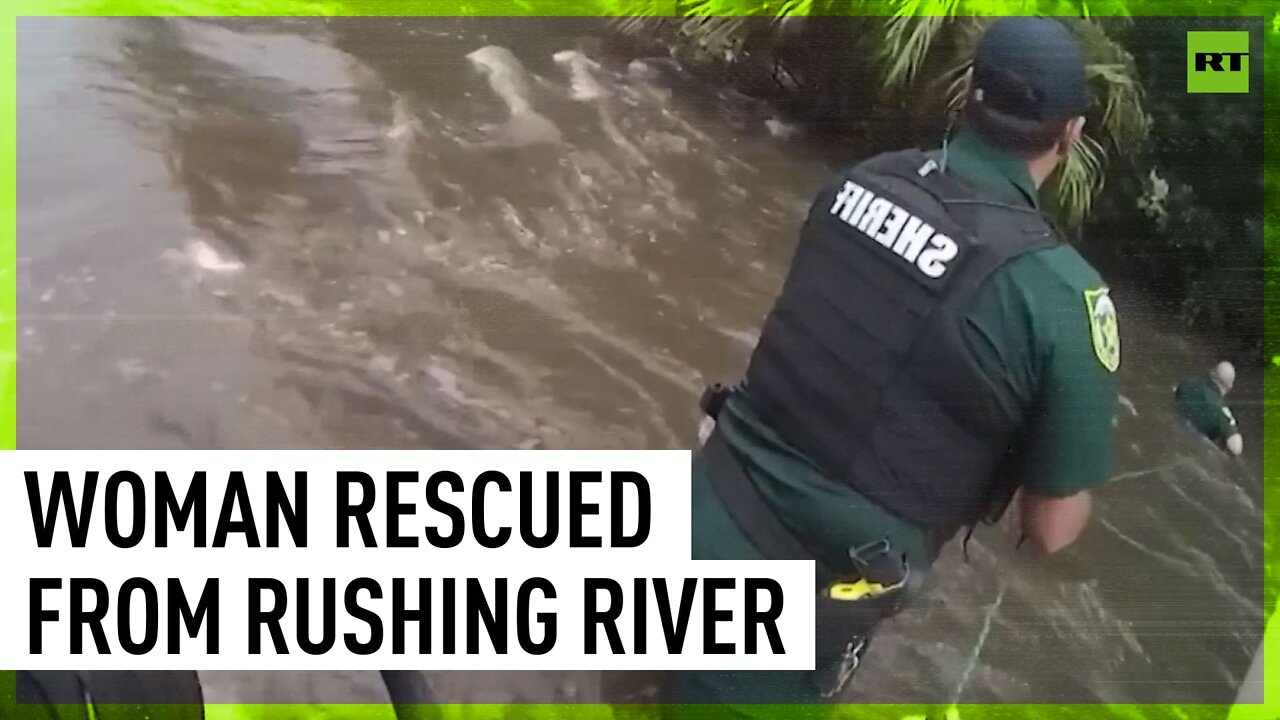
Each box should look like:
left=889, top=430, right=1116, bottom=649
left=699, top=383, right=910, bottom=700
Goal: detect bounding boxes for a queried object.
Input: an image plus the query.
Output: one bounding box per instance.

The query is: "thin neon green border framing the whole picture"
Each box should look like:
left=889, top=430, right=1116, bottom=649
left=0, top=0, right=1280, bottom=720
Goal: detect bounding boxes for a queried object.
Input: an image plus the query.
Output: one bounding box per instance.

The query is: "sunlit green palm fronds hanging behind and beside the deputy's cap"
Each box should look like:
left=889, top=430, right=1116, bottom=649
left=618, top=0, right=1149, bottom=224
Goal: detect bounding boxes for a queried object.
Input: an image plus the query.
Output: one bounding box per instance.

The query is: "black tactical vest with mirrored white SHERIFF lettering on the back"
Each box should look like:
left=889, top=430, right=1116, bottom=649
left=745, top=150, right=1059, bottom=537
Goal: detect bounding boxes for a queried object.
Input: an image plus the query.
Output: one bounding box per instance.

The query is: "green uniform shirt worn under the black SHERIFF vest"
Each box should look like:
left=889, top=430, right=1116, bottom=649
left=694, top=131, right=1119, bottom=568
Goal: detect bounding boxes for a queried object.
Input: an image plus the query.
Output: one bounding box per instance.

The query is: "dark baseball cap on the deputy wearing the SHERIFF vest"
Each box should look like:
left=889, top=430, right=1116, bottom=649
left=972, top=17, right=1089, bottom=122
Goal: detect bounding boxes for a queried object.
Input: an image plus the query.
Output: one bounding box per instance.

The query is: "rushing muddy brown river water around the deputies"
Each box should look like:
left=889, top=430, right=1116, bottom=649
left=18, top=18, right=1262, bottom=703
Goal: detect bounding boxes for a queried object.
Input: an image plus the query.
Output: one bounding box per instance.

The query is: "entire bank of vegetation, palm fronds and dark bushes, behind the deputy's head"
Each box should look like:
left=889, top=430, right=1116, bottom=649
left=614, top=7, right=1270, bottom=360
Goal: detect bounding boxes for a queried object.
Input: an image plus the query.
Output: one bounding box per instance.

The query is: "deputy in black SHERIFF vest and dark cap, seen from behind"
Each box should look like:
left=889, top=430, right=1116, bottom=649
left=666, top=18, right=1120, bottom=716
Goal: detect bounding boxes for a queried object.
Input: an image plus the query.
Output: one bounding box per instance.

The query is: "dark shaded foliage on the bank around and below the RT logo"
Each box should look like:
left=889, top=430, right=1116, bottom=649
left=1085, top=14, right=1275, bottom=361
